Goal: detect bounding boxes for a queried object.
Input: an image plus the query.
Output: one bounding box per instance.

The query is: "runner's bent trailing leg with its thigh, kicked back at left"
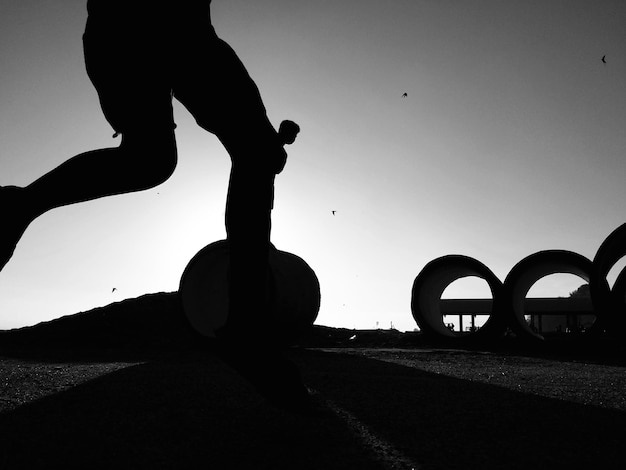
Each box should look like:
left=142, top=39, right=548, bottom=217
left=0, top=1, right=177, bottom=269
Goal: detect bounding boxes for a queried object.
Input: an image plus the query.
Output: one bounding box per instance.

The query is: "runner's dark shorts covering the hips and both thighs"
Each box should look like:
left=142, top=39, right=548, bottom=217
left=83, top=2, right=285, bottom=174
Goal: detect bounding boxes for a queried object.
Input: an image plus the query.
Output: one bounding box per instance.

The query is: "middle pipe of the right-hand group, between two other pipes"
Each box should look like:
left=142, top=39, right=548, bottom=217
left=502, top=250, right=600, bottom=340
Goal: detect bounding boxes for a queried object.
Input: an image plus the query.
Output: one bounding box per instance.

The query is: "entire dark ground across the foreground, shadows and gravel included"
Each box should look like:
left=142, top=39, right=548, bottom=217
left=0, top=292, right=626, bottom=469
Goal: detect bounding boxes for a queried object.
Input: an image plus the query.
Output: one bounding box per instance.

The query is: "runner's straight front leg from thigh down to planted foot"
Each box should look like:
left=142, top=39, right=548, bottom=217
left=174, top=36, right=311, bottom=412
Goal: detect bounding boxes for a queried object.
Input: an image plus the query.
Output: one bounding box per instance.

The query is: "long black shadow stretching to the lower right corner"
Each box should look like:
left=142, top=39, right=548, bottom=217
left=298, top=352, right=626, bottom=470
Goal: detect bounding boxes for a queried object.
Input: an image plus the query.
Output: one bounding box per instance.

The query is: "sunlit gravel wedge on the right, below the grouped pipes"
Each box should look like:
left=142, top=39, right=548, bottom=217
left=326, top=348, right=626, bottom=411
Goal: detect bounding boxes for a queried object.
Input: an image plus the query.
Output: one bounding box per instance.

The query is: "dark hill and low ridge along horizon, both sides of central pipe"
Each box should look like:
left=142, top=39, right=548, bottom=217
left=0, top=292, right=626, bottom=364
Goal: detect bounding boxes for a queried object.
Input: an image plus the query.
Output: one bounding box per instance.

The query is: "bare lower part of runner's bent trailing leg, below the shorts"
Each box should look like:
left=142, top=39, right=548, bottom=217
left=0, top=130, right=177, bottom=269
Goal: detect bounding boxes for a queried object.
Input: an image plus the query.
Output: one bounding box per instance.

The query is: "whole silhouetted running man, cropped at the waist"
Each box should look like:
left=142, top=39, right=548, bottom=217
left=0, top=0, right=306, bottom=412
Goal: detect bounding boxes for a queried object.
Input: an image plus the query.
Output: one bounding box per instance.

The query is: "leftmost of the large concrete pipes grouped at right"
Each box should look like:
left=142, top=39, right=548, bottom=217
left=411, top=255, right=505, bottom=341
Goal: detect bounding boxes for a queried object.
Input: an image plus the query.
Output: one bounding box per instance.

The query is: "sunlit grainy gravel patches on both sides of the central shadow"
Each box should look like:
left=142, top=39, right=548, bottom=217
left=0, top=348, right=626, bottom=412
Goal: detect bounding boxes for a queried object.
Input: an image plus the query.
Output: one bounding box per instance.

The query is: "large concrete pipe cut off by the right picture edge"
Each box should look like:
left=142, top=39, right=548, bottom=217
left=589, top=224, right=626, bottom=333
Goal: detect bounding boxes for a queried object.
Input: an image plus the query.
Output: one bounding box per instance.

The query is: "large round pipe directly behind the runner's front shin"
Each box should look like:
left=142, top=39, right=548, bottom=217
left=179, top=240, right=321, bottom=343
